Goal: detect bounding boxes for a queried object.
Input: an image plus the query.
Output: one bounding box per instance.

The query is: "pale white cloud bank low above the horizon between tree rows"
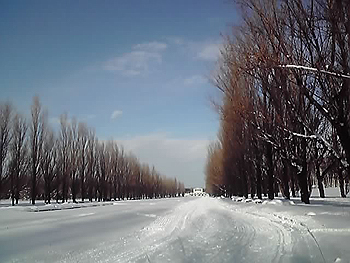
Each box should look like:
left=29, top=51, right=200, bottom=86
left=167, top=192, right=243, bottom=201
left=117, top=133, right=209, bottom=186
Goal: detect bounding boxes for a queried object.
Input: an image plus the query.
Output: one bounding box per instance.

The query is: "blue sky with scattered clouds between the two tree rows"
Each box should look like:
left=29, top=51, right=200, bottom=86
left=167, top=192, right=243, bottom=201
left=0, top=0, right=237, bottom=189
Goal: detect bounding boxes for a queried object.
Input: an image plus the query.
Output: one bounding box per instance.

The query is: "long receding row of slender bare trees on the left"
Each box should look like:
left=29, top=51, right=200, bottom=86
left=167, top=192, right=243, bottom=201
left=0, top=97, right=184, bottom=205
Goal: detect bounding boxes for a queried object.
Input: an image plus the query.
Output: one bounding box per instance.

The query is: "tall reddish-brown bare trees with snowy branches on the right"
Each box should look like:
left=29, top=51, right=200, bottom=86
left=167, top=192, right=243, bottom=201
left=206, top=0, right=350, bottom=203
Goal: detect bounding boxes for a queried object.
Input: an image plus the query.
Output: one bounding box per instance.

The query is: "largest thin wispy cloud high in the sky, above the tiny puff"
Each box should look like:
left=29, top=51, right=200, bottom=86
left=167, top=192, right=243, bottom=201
left=104, top=42, right=167, bottom=76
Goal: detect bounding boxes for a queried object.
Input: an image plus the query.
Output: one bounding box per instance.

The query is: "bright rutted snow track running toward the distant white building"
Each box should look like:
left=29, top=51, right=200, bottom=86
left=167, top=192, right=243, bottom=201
left=60, top=198, right=324, bottom=263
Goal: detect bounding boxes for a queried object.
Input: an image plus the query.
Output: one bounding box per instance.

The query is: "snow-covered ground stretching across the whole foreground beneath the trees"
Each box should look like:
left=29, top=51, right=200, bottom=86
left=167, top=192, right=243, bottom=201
left=0, top=189, right=350, bottom=262
